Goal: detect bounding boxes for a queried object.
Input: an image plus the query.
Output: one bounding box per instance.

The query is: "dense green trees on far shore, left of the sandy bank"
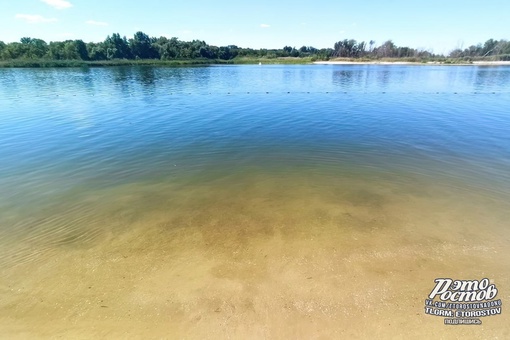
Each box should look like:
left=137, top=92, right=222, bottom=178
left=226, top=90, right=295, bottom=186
left=0, top=32, right=332, bottom=61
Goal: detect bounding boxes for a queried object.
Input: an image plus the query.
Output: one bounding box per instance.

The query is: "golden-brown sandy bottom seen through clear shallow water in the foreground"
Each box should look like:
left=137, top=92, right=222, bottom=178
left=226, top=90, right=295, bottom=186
left=0, top=174, right=510, bottom=339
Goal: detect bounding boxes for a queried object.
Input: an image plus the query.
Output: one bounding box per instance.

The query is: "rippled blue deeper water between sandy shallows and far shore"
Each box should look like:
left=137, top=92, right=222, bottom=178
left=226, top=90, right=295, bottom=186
left=0, top=65, right=510, bottom=263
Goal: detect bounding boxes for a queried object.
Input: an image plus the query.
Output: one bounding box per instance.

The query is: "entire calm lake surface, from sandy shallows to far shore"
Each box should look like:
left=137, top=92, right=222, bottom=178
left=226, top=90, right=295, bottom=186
left=0, top=65, right=510, bottom=338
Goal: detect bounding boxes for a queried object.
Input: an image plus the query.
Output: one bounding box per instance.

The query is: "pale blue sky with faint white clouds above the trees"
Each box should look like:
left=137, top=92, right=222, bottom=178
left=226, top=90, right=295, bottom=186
left=0, top=0, right=510, bottom=53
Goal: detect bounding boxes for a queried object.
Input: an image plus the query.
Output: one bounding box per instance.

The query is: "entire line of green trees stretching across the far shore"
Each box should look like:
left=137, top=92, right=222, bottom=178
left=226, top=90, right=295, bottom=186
left=0, top=32, right=510, bottom=61
